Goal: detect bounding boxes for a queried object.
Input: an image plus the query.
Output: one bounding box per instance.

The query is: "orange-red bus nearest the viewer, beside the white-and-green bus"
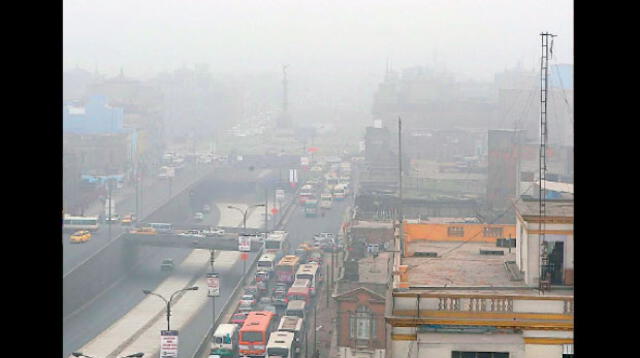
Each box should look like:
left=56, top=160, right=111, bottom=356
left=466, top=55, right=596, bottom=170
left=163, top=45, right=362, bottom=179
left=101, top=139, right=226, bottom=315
left=238, top=311, right=276, bottom=356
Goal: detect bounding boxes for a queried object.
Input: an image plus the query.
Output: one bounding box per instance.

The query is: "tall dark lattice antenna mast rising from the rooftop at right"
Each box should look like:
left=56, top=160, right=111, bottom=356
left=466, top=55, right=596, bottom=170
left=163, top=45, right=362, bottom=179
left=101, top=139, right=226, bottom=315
left=538, top=32, right=556, bottom=290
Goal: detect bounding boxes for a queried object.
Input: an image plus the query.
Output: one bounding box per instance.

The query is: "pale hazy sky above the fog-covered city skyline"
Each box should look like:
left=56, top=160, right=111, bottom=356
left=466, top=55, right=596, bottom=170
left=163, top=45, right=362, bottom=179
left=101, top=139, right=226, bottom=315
left=63, top=0, right=573, bottom=80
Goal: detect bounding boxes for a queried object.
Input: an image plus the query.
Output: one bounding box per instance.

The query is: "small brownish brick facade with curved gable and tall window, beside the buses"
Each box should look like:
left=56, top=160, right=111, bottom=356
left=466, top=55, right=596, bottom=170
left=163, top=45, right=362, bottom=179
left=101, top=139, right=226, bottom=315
left=335, top=287, right=387, bottom=358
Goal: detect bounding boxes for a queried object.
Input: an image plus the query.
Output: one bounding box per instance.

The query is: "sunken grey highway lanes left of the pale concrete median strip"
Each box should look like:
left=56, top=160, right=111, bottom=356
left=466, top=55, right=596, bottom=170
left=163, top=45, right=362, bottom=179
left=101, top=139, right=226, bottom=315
left=63, top=200, right=220, bottom=357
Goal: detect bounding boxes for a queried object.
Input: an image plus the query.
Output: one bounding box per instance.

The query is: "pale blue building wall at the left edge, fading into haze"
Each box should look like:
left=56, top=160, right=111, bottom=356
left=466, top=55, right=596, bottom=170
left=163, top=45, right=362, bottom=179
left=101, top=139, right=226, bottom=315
left=62, top=95, right=128, bottom=134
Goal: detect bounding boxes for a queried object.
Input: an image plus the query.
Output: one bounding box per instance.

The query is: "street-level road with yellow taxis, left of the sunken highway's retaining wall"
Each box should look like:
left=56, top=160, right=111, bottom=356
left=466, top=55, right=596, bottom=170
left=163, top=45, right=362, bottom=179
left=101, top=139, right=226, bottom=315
left=62, top=166, right=210, bottom=275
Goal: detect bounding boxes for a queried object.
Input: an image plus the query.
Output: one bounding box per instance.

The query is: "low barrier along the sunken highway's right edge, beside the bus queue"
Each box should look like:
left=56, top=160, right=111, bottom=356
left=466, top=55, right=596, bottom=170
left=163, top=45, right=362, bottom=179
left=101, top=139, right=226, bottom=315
left=193, top=193, right=297, bottom=358
